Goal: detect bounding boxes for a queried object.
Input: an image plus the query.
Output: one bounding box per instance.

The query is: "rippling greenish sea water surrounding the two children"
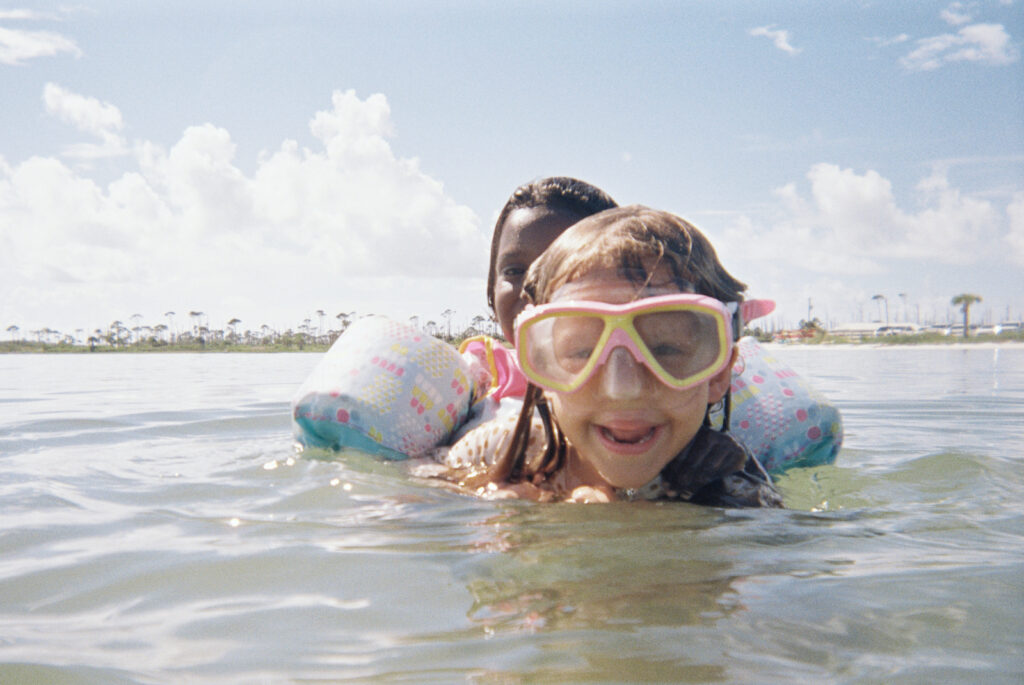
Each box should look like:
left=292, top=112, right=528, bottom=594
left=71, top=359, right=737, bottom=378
left=0, top=347, right=1024, bottom=685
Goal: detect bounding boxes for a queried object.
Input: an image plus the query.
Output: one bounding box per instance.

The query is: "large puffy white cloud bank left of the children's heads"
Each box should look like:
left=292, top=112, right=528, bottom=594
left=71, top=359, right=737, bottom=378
left=0, top=86, right=487, bottom=333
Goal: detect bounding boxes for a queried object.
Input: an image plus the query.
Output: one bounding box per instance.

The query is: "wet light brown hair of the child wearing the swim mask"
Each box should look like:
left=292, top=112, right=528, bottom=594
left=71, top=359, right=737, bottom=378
left=452, top=205, right=746, bottom=488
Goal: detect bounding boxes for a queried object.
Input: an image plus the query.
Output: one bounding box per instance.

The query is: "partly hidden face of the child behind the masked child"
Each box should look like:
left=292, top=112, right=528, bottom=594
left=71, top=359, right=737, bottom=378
left=495, top=207, right=580, bottom=340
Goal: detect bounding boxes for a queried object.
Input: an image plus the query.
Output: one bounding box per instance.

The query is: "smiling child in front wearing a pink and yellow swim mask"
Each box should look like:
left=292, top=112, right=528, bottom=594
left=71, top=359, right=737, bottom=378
left=434, top=206, right=781, bottom=507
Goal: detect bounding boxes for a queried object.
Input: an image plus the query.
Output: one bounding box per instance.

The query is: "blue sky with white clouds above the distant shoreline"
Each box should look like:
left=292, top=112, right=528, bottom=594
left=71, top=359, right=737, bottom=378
left=0, top=0, right=1024, bottom=339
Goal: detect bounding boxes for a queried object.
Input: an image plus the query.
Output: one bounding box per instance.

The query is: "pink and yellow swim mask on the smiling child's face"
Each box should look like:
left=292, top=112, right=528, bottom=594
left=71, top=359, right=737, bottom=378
left=515, top=293, right=737, bottom=392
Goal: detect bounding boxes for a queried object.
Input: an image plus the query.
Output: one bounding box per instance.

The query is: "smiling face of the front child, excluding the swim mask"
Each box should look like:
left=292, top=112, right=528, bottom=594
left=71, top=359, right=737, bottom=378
left=546, top=271, right=731, bottom=487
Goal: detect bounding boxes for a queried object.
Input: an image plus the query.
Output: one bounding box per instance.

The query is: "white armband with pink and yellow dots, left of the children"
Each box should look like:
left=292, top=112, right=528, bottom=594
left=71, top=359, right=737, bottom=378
left=292, top=316, right=475, bottom=460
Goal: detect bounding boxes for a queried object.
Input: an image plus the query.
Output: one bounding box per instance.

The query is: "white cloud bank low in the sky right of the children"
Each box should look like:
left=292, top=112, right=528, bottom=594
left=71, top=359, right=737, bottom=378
left=714, top=163, right=1024, bottom=325
